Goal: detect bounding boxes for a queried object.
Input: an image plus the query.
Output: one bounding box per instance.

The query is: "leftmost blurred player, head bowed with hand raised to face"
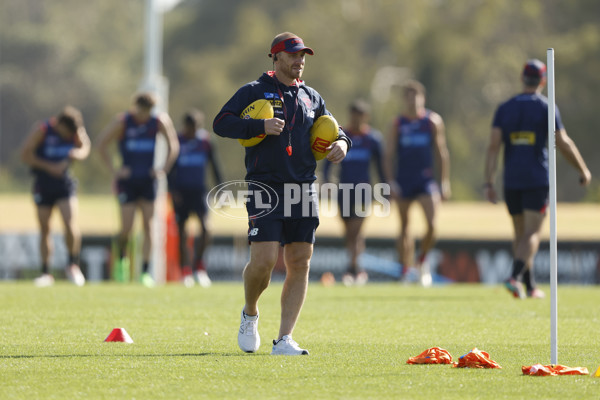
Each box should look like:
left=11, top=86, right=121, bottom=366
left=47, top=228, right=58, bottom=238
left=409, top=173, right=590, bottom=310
left=22, top=106, right=90, bottom=286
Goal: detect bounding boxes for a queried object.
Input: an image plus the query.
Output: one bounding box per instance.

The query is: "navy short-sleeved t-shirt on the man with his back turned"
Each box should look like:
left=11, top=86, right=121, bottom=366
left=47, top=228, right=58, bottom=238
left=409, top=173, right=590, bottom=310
left=492, top=93, right=564, bottom=189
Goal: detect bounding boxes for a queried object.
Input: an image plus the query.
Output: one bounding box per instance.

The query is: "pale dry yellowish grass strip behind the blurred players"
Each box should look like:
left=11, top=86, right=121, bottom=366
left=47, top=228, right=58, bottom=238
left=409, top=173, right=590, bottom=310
left=0, top=194, right=600, bottom=240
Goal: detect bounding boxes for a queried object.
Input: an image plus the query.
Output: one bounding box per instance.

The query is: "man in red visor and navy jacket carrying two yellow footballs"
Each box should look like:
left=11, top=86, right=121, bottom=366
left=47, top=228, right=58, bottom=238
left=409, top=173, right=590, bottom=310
left=214, top=32, right=352, bottom=355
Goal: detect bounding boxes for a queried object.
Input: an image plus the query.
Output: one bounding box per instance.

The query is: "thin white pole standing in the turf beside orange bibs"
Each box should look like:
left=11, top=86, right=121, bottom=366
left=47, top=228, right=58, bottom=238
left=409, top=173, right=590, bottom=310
left=546, top=49, right=558, bottom=364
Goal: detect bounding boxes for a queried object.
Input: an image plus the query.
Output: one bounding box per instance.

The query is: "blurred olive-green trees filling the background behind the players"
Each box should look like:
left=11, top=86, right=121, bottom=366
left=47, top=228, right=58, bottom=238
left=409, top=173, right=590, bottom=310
left=0, top=0, right=600, bottom=201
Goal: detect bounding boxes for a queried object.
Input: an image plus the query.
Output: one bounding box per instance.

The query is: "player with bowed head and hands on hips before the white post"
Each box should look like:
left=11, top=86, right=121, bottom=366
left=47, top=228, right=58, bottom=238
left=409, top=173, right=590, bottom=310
left=99, top=93, right=179, bottom=286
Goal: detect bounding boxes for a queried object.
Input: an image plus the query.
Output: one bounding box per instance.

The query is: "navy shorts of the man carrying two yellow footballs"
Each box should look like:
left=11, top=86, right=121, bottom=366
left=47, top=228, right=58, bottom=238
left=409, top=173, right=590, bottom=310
left=246, top=184, right=319, bottom=246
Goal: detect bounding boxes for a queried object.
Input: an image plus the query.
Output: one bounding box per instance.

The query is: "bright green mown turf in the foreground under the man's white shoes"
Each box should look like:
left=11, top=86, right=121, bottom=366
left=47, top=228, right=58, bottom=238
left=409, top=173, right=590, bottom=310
left=0, top=282, right=600, bottom=400
